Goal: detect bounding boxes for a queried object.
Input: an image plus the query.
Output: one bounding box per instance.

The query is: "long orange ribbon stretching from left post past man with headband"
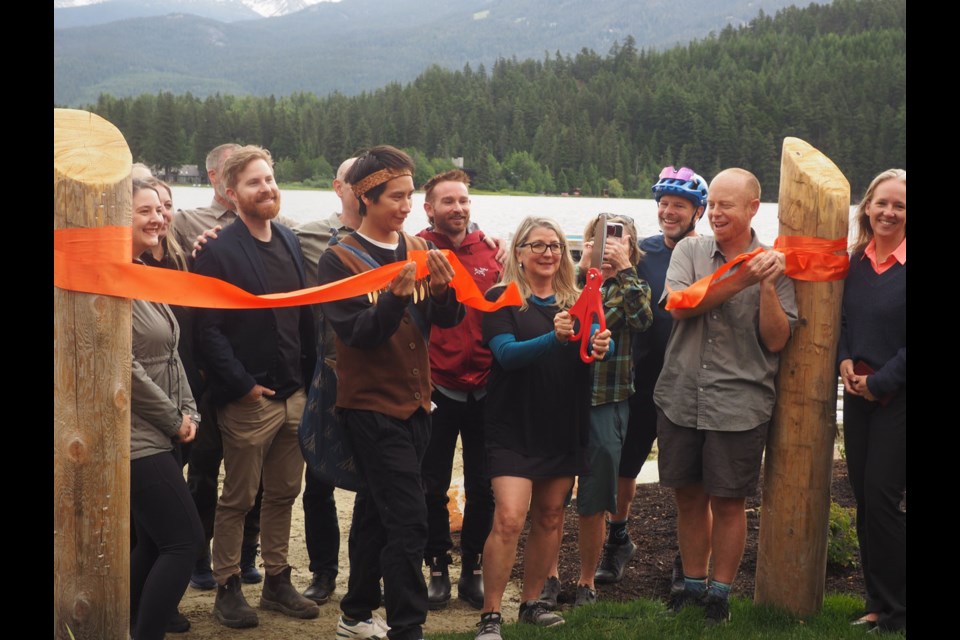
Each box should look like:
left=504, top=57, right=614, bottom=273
left=53, top=227, right=522, bottom=311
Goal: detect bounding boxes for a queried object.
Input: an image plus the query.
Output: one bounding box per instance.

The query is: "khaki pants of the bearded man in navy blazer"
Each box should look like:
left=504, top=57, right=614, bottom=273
left=213, top=389, right=306, bottom=584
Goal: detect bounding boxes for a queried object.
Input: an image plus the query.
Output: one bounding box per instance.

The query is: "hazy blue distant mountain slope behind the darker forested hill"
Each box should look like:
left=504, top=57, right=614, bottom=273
left=53, top=0, right=808, bottom=105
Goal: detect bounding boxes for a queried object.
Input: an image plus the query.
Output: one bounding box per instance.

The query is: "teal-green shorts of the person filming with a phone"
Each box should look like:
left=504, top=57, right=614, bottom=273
left=577, top=400, right=630, bottom=516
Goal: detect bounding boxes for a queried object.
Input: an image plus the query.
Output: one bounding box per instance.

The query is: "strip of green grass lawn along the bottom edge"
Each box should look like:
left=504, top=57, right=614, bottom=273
left=430, top=595, right=898, bottom=640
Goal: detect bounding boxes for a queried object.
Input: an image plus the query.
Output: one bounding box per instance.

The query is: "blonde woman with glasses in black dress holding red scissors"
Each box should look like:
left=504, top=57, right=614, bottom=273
left=476, top=217, right=610, bottom=640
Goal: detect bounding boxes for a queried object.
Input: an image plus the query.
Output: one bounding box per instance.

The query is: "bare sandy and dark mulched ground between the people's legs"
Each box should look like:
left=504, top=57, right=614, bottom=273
left=167, top=461, right=863, bottom=640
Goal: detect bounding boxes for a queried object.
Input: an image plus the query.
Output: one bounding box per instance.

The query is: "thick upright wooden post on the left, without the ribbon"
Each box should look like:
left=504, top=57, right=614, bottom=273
left=53, top=109, right=131, bottom=640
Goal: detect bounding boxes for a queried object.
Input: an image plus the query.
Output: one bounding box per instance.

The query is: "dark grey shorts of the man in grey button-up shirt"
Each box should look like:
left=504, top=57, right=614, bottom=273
left=657, top=408, right=770, bottom=498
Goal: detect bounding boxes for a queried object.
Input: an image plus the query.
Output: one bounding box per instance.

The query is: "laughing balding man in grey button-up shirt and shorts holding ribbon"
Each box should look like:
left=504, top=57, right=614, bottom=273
left=654, top=169, right=797, bottom=624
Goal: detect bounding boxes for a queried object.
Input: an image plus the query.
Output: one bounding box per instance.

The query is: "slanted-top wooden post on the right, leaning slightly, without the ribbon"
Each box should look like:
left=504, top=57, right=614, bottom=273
left=755, top=138, right=850, bottom=616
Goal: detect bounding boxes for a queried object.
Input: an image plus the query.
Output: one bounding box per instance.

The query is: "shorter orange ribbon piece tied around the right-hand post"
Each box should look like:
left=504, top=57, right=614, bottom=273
left=665, top=236, right=850, bottom=311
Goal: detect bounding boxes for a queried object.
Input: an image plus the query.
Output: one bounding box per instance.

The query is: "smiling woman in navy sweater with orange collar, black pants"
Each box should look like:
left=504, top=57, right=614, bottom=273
left=837, top=169, right=907, bottom=632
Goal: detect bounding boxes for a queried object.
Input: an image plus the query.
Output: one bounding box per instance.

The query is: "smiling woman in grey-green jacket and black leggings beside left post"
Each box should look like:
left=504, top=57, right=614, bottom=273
left=130, top=180, right=203, bottom=640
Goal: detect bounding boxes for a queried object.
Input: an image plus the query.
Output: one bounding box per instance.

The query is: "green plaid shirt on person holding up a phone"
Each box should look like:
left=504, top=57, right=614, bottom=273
left=577, top=267, right=653, bottom=407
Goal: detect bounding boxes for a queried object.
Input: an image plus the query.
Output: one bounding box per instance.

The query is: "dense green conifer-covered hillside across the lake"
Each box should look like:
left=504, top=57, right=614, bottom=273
left=84, top=0, right=907, bottom=200
